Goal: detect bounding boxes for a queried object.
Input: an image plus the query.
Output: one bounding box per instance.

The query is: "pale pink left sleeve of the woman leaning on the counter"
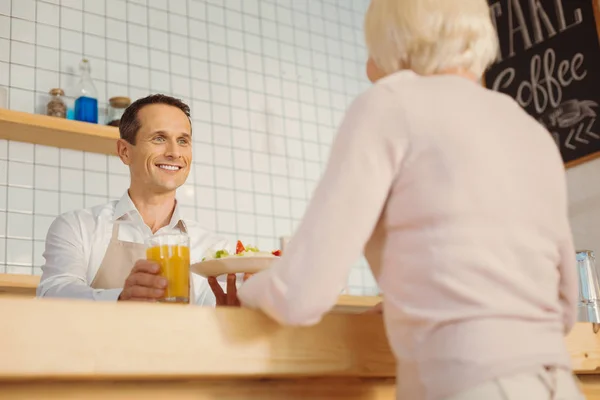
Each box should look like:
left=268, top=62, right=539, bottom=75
left=239, top=86, right=408, bottom=325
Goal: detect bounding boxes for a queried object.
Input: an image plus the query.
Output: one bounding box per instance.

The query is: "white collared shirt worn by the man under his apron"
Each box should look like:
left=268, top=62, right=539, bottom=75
left=37, top=192, right=231, bottom=305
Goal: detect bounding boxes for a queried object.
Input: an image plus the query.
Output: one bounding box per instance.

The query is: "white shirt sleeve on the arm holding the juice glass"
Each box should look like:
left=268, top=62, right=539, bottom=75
left=37, top=213, right=122, bottom=301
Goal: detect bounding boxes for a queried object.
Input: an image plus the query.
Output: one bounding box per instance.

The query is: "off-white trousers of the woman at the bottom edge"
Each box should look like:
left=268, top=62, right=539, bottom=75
left=445, top=367, right=585, bottom=400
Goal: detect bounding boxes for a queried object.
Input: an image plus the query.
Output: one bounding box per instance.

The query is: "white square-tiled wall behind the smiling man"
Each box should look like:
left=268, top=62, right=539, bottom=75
left=0, top=0, right=377, bottom=294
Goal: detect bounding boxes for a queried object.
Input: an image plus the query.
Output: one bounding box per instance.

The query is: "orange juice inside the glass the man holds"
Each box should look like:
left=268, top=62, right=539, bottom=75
left=146, top=244, right=190, bottom=303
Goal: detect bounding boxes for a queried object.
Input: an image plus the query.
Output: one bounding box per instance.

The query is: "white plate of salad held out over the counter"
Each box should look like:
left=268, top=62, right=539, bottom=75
left=190, top=240, right=281, bottom=278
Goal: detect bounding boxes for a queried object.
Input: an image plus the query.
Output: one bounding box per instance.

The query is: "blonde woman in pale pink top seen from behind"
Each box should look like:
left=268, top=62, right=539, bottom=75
left=239, top=0, right=583, bottom=400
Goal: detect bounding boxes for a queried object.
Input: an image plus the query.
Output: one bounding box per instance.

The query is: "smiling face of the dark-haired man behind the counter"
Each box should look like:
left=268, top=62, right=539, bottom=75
left=120, top=104, right=192, bottom=194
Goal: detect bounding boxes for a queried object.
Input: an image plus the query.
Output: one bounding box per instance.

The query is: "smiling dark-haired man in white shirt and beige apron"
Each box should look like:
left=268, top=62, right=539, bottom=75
left=37, top=94, right=235, bottom=305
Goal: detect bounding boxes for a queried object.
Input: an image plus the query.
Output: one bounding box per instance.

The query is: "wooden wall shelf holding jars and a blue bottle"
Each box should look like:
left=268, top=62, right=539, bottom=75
left=0, top=108, right=119, bottom=154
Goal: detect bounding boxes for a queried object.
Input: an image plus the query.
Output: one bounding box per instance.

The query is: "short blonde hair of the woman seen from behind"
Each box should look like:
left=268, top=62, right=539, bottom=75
left=365, top=0, right=498, bottom=78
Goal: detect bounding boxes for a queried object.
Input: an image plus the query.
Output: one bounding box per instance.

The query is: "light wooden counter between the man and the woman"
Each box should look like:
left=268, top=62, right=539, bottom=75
left=0, top=297, right=600, bottom=400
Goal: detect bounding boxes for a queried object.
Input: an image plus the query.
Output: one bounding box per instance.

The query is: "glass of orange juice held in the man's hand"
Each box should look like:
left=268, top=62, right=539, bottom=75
left=146, top=232, right=190, bottom=303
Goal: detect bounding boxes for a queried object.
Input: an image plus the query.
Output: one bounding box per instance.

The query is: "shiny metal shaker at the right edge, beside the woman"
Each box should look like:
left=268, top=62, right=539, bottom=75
left=576, top=250, right=600, bottom=323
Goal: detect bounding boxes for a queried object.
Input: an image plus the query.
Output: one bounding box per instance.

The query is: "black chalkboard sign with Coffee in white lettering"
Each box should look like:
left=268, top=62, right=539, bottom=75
left=485, top=0, right=600, bottom=165
